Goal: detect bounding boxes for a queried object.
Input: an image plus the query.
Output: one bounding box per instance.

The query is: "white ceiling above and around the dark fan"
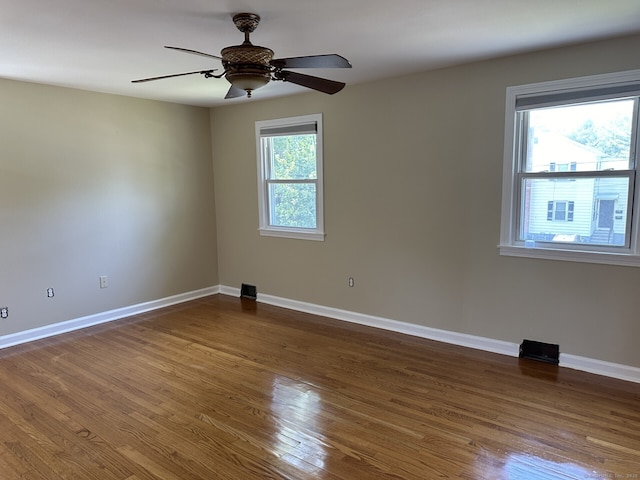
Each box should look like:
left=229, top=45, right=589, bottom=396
left=0, top=0, right=640, bottom=106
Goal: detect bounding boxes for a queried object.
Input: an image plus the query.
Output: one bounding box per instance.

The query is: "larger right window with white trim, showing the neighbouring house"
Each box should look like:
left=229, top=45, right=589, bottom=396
left=500, top=70, right=640, bottom=266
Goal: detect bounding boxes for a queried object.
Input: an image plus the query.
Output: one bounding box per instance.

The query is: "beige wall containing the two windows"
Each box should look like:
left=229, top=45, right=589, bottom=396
left=211, top=36, right=640, bottom=367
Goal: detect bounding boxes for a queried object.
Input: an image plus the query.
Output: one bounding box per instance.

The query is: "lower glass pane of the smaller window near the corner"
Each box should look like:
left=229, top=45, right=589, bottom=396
left=269, top=183, right=316, bottom=228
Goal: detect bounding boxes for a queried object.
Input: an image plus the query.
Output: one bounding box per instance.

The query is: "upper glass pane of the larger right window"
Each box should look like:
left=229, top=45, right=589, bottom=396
left=519, top=100, right=634, bottom=172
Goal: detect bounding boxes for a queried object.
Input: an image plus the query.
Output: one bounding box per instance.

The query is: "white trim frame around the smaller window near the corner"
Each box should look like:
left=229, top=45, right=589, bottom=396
left=255, top=113, right=325, bottom=241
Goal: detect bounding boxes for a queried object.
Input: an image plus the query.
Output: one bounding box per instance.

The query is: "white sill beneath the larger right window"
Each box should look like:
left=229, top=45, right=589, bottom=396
left=498, top=245, right=640, bottom=267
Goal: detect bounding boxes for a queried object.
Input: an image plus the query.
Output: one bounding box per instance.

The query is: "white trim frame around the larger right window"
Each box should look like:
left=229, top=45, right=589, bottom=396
left=498, top=70, right=640, bottom=267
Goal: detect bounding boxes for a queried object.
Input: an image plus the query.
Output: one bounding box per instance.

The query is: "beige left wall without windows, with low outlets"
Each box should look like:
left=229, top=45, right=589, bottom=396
left=0, top=80, right=218, bottom=336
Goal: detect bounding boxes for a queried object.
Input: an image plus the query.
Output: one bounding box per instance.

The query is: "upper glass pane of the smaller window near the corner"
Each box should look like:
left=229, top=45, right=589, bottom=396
left=266, top=134, right=317, bottom=180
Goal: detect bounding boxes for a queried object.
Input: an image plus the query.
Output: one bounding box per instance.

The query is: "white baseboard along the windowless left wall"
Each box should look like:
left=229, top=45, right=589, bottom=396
left=0, top=286, right=220, bottom=349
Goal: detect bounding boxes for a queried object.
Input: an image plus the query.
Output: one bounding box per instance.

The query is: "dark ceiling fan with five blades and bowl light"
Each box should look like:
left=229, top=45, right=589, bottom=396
left=133, top=13, right=351, bottom=98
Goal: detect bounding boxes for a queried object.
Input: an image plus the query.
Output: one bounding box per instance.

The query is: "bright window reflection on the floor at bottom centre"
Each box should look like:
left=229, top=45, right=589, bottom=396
left=271, top=376, right=327, bottom=474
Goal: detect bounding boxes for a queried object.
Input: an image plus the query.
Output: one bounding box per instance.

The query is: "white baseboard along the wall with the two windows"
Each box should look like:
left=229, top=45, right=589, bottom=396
left=220, top=286, right=640, bottom=383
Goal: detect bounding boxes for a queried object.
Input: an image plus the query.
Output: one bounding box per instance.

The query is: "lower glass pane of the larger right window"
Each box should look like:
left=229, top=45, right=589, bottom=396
left=520, top=177, right=629, bottom=246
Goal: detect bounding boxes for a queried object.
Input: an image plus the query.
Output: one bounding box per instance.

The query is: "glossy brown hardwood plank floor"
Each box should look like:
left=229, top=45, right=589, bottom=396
left=0, top=295, right=640, bottom=480
